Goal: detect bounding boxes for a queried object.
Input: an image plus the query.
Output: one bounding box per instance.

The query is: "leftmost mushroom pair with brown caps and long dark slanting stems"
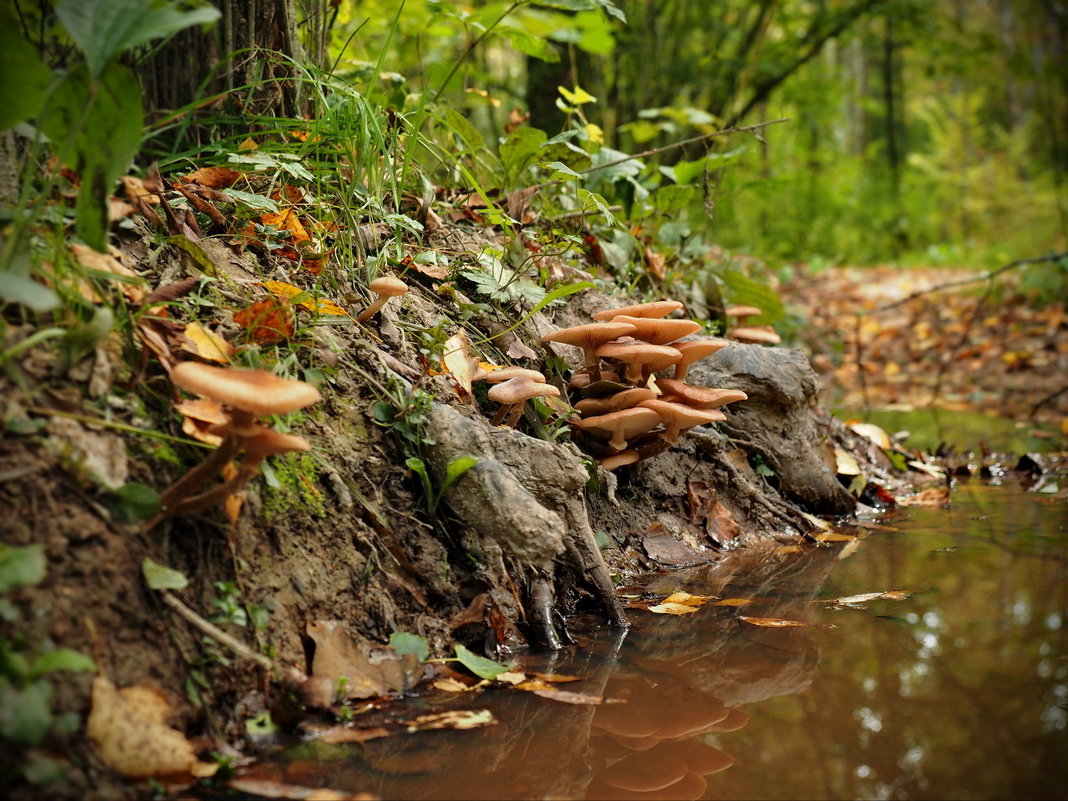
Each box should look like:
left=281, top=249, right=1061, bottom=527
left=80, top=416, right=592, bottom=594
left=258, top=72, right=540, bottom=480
left=145, top=361, right=321, bottom=529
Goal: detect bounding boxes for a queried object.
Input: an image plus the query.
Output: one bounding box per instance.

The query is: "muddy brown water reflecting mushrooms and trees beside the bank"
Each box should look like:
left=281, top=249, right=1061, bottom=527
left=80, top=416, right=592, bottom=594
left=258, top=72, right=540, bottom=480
left=245, top=483, right=1068, bottom=799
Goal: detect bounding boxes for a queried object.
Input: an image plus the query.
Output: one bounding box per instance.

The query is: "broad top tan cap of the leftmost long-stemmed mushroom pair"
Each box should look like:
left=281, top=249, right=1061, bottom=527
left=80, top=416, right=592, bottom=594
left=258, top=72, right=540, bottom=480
left=171, top=361, right=323, bottom=415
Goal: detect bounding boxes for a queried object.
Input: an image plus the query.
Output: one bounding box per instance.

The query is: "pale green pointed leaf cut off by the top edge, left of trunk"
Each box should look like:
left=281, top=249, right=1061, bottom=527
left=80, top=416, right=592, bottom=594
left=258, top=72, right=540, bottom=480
left=56, top=0, right=221, bottom=78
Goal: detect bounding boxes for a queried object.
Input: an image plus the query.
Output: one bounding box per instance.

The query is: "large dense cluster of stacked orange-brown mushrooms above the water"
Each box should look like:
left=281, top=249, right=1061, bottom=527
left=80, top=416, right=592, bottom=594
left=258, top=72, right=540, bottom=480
left=541, top=300, right=747, bottom=470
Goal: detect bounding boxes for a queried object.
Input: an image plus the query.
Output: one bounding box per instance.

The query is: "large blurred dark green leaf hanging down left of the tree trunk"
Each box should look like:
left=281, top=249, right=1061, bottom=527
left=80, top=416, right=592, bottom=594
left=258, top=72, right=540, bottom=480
left=37, top=64, right=144, bottom=251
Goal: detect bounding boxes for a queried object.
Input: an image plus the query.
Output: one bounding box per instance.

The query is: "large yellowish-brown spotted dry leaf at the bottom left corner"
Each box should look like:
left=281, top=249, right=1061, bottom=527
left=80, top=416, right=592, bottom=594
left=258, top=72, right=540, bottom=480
left=85, top=676, right=219, bottom=779
